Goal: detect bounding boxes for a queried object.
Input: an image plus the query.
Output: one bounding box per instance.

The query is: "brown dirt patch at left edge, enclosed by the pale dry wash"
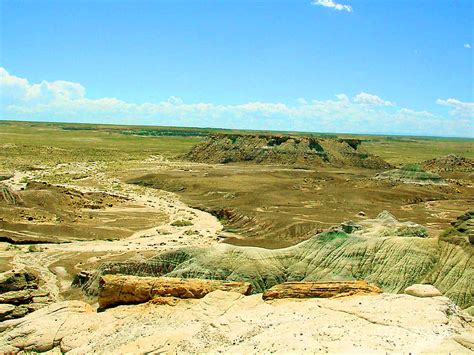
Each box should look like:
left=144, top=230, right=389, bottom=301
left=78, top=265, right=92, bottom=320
left=0, top=182, right=167, bottom=244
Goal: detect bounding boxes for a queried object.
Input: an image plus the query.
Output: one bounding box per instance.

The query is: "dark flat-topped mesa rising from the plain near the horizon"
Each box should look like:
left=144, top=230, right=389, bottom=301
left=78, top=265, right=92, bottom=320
left=185, top=134, right=391, bottom=169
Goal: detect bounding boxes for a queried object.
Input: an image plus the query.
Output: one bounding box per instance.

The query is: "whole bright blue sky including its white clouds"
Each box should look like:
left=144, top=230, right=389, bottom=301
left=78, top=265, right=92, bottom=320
left=0, top=0, right=474, bottom=137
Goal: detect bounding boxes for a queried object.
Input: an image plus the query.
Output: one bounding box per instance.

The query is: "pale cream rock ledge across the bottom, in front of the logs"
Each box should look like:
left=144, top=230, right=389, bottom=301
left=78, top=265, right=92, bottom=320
left=0, top=290, right=474, bottom=354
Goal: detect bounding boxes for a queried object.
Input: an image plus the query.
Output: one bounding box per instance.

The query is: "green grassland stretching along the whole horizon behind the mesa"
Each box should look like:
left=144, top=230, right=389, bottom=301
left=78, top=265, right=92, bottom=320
left=0, top=121, right=474, bottom=169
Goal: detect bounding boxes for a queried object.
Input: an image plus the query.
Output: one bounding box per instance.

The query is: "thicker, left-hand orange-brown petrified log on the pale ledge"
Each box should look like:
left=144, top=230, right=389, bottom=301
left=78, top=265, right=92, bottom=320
left=99, top=275, right=252, bottom=308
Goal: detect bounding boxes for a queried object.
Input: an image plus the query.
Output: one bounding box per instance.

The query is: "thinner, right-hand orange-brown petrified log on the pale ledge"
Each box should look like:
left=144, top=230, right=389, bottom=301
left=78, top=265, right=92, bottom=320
left=262, top=280, right=382, bottom=300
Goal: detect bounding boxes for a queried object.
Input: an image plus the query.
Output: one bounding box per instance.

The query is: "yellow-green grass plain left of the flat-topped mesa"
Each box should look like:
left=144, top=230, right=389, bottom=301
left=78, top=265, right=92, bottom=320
left=0, top=121, right=203, bottom=171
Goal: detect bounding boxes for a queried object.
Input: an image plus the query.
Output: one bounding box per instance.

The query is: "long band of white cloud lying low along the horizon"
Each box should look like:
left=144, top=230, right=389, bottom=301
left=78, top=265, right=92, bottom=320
left=0, top=68, right=474, bottom=136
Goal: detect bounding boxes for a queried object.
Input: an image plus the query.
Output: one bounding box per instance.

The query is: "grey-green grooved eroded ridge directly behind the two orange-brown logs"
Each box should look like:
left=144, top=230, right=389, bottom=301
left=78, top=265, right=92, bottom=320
left=84, top=213, right=474, bottom=309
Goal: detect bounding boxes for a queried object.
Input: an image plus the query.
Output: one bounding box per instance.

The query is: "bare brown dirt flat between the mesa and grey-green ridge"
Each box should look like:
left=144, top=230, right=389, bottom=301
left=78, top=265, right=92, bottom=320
left=123, top=164, right=474, bottom=248
